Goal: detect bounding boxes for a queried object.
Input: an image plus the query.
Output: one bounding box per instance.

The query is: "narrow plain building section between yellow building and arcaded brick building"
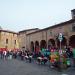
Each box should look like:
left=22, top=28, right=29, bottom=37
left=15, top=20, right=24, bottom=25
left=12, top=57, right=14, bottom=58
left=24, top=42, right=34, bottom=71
left=18, top=28, right=39, bottom=50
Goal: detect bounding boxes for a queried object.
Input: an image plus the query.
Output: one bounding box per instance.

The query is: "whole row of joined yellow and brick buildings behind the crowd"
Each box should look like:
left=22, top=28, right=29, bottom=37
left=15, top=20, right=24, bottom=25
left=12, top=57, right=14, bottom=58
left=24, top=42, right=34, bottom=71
left=0, top=9, right=75, bottom=52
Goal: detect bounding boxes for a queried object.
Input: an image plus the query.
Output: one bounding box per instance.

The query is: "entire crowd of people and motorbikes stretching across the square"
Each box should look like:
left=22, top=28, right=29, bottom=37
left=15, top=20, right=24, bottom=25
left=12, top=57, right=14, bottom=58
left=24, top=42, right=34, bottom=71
left=0, top=47, right=75, bottom=68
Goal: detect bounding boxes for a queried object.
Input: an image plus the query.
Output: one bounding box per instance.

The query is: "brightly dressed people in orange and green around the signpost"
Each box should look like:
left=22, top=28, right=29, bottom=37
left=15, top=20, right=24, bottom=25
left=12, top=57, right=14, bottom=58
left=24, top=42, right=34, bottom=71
left=50, top=46, right=75, bottom=69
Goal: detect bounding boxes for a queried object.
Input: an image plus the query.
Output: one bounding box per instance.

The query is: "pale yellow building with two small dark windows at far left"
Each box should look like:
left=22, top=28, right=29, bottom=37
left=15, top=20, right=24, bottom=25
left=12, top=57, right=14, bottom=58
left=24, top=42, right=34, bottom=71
left=0, top=29, right=19, bottom=50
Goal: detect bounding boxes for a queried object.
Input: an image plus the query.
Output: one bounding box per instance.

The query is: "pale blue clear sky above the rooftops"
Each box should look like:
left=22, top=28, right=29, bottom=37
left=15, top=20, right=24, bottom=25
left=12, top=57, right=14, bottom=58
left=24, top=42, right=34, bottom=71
left=0, top=0, right=75, bottom=32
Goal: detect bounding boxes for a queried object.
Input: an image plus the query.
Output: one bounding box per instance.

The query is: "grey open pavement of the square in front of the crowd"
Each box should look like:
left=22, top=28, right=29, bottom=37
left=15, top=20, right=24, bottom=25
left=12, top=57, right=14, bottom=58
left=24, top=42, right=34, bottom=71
left=0, top=59, right=75, bottom=75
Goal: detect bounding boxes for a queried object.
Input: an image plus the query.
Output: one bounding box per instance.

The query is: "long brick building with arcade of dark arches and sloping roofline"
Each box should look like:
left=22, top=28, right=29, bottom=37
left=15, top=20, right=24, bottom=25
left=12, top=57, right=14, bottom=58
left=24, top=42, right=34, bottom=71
left=26, top=9, right=75, bottom=52
